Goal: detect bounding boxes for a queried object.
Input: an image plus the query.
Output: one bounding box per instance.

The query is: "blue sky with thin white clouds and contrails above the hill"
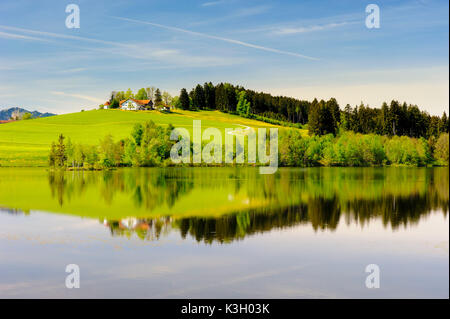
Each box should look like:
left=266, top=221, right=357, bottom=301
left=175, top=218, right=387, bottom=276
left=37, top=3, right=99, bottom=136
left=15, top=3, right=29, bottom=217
left=0, top=0, right=449, bottom=115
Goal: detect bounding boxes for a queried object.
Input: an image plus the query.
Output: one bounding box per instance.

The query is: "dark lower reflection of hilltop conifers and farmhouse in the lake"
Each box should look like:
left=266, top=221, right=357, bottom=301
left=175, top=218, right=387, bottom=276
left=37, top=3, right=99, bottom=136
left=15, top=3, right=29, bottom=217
left=101, top=189, right=448, bottom=243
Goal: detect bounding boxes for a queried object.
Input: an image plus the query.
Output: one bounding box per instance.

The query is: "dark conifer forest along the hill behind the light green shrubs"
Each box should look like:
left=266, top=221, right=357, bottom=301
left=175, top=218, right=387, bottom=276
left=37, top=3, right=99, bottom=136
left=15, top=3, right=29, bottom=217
left=174, top=82, right=449, bottom=139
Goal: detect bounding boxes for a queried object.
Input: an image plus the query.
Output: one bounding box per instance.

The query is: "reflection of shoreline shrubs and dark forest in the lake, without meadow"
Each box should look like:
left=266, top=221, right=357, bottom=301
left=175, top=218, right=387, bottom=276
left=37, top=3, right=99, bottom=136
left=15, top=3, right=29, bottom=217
left=49, top=168, right=449, bottom=243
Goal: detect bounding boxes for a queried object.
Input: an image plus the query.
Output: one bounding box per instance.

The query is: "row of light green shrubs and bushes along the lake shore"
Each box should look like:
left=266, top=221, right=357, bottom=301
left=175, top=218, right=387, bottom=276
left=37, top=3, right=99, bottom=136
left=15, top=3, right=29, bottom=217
left=49, top=121, right=449, bottom=170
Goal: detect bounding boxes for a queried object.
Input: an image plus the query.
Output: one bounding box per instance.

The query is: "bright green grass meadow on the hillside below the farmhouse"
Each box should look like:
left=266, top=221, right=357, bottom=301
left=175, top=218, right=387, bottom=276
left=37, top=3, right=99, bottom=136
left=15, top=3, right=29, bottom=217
left=0, top=110, right=306, bottom=167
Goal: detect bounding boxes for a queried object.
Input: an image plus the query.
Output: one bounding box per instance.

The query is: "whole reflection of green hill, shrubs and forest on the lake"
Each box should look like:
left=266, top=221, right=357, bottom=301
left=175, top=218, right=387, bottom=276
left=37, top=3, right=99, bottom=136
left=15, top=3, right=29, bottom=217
left=0, top=168, right=442, bottom=243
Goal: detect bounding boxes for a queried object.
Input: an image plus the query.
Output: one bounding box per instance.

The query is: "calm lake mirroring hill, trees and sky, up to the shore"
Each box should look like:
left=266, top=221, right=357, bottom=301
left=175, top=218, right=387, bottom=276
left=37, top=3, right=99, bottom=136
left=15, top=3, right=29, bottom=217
left=0, top=168, right=449, bottom=298
